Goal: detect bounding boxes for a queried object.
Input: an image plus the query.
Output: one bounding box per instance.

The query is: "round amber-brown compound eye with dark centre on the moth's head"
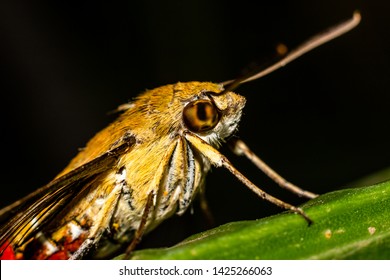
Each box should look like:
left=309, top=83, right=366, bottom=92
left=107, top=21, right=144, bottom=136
left=183, top=100, right=219, bottom=132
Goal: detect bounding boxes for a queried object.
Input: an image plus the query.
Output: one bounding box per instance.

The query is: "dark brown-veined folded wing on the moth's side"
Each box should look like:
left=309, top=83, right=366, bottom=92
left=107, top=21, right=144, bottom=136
left=0, top=137, right=135, bottom=255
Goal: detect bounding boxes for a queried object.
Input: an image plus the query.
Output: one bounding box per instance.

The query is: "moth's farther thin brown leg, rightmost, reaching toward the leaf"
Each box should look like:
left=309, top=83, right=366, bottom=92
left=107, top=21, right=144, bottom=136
left=229, top=139, right=318, bottom=198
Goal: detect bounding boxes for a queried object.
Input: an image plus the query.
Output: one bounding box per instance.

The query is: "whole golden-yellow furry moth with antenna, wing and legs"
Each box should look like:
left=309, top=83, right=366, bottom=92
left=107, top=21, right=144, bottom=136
left=0, top=12, right=360, bottom=259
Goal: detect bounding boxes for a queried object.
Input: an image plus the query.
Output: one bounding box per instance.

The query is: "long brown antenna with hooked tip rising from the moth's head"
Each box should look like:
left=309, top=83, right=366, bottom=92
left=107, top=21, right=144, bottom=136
left=215, top=11, right=361, bottom=95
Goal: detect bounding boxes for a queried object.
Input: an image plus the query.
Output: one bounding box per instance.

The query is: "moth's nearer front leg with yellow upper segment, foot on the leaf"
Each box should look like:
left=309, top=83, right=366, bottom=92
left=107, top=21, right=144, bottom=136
left=184, top=131, right=312, bottom=224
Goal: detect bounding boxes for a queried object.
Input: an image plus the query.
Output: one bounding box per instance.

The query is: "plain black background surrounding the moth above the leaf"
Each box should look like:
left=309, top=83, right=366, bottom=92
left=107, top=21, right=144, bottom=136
left=0, top=0, right=390, bottom=249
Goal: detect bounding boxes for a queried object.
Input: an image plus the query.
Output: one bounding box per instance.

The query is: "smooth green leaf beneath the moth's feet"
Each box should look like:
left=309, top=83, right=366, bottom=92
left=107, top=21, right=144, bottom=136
left=118, top=181, right=390, bottom=259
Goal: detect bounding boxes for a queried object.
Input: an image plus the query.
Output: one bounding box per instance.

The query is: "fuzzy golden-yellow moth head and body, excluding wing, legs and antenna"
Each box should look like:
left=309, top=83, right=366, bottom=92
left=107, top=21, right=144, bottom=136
left=3, top=82, right=245, bottom=259
